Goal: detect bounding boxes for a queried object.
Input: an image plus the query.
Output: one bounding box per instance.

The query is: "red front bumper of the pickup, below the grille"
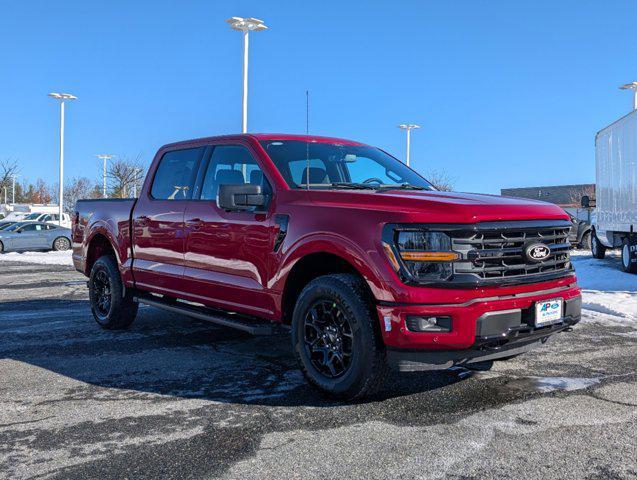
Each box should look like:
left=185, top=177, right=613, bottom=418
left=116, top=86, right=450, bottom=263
left=377, top=284, right=581, bottom=370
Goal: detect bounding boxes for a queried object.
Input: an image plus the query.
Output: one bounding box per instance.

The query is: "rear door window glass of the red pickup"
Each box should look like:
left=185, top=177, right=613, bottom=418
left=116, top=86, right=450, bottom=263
left=150, top=147, right=204, bottom=200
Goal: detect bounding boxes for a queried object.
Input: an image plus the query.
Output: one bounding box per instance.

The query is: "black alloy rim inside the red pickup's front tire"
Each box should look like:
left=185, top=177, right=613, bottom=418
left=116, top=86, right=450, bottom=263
left=303, top=300, right=354, bottom=378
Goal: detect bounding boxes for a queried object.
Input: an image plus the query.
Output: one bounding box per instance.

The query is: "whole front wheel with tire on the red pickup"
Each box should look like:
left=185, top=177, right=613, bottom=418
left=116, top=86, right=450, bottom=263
left=291, top=274, right=389, bottom=401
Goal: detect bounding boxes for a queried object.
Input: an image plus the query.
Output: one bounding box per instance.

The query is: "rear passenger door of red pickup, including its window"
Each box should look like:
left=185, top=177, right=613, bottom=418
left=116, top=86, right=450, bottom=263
left=132, top=147, right=206, bottom=296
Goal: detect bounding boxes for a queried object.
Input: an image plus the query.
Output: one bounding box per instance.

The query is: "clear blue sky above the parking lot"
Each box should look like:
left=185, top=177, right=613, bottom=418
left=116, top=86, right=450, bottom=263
left=0, top=0, right=637, bottom=193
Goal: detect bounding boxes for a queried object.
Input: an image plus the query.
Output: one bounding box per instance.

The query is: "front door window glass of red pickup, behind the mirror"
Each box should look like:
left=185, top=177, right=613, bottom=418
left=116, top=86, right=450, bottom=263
left=200, top=145, right=272, bottom=200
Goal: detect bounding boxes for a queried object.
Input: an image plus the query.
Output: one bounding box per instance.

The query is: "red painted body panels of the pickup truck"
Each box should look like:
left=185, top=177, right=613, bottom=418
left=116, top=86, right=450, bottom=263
left=73, top=134, right=579, bottom=349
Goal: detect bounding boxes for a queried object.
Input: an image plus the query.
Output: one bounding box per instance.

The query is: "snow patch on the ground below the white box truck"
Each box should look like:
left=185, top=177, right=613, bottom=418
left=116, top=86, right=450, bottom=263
left=572, top=251, right=637, bottom=328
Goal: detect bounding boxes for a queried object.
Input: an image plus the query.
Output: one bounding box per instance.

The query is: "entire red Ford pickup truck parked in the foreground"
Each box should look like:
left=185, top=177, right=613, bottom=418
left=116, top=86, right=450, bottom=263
left=72, top=134, right=581, bottom=399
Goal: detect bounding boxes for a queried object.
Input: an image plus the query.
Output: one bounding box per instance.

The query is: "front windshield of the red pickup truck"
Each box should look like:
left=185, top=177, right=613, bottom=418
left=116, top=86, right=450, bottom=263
left=261, top=140, right=434, bottom=190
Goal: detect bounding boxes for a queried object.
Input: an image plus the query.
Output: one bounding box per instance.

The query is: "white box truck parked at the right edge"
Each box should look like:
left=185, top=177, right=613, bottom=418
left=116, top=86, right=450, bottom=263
left=582, top=110, right=637, bottom=273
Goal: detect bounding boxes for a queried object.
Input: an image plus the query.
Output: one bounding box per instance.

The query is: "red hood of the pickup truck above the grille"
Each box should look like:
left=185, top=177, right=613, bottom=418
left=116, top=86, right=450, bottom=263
left=308, top=190, right=568, bottom=223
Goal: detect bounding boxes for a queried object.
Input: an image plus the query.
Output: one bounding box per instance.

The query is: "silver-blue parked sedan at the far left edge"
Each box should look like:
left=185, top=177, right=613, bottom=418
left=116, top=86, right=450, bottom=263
left=0, top=222, right=71, bottom=252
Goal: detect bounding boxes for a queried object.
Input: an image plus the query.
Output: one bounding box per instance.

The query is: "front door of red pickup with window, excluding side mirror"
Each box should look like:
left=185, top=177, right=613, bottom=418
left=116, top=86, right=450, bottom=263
left=184, top=145, right=274, bottom=317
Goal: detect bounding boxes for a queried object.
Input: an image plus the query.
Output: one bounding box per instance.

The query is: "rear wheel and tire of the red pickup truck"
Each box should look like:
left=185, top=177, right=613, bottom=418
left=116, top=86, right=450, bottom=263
left=88, top=255, right=138, bottom=330
